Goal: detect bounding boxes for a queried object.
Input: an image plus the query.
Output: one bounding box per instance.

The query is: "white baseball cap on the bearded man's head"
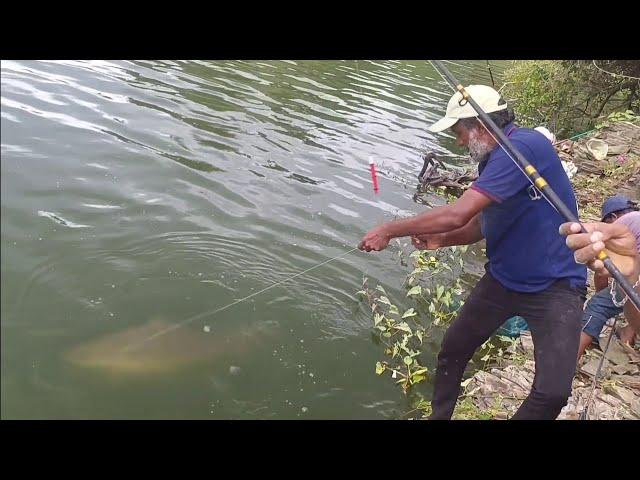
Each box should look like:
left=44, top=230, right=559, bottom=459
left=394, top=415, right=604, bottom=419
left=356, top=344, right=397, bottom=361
left=429, top=85, right=507, bottom=132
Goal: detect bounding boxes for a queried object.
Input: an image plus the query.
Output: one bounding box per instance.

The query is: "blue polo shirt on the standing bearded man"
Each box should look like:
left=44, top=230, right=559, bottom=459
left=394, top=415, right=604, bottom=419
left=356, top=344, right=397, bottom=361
left=471, top=123, right=587, bottom=292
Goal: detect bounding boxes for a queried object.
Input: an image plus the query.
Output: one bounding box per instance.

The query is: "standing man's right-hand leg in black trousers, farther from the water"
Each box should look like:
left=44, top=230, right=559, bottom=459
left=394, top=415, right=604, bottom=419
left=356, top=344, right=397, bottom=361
left=512, top=282, right=584, bottom=420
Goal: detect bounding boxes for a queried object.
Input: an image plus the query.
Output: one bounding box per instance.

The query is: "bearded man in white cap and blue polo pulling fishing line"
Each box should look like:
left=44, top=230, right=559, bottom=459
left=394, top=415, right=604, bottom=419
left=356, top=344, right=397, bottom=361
left=359, top=85, right=586, bottom=419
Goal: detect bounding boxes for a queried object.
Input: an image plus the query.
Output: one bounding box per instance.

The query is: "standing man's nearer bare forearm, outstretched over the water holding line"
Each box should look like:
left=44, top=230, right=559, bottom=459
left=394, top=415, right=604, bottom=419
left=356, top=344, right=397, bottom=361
left=358, top=189, right=492, bottom=252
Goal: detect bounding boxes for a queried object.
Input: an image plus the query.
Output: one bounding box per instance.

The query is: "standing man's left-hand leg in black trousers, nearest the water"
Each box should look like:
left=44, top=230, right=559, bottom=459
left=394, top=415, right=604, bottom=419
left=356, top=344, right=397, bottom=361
left=429, top=273, right=514, bottom=420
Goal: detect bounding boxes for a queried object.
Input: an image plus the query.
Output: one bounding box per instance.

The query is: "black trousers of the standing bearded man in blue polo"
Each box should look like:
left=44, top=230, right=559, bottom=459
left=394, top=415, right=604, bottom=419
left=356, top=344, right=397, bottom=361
left=429, top=272, right=586, bottom=420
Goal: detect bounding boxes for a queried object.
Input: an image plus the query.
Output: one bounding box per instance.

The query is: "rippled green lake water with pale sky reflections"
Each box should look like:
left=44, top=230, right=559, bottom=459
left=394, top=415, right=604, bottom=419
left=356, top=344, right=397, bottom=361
left=0, top=61, right=499, bottom=418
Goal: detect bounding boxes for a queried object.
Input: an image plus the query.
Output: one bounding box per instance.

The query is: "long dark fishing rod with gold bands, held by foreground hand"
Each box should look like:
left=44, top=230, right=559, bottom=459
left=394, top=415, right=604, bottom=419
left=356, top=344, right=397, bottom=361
left=429, top=60, right=640, bottom=310
